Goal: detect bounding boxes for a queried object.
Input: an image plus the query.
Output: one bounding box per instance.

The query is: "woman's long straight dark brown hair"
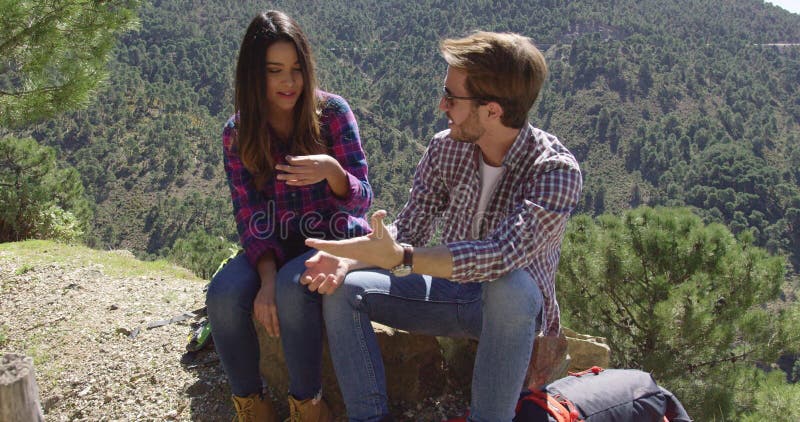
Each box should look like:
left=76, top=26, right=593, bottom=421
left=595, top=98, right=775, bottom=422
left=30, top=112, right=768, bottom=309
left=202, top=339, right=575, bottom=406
left=235, top=10, right=325, bottom=188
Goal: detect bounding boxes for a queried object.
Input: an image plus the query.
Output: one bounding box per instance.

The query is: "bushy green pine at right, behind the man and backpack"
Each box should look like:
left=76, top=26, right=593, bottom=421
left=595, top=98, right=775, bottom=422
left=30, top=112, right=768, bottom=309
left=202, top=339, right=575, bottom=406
left=558, top=207, right=789, bottom=420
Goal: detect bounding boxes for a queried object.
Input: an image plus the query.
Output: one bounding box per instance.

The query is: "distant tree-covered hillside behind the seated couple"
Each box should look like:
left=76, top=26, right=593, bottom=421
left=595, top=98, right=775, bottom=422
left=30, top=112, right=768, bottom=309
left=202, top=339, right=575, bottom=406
left=10, top=0, right=800, bottom=270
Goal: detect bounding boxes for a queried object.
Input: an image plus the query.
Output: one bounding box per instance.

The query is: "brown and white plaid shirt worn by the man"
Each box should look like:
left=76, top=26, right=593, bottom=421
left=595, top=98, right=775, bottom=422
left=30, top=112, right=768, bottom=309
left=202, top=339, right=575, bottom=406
left=394, top=125, right=582, bottom=335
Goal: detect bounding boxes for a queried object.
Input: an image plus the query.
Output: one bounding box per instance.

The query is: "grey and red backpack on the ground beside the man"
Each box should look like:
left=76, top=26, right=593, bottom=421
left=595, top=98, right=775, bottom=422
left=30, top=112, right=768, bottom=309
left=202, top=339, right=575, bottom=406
left=514, top=366, right=691, bottom=422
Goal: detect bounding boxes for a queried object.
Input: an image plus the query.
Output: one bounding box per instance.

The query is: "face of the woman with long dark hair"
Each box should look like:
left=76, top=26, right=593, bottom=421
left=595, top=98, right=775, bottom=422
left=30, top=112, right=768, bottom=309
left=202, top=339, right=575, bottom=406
left=267, top=41, right=303, bottom=112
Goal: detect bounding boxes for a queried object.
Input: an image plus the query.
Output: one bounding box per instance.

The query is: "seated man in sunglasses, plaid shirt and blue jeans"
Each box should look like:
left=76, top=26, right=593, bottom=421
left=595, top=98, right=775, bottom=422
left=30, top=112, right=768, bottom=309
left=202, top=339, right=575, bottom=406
left=277, top=32, right=582, bottom=422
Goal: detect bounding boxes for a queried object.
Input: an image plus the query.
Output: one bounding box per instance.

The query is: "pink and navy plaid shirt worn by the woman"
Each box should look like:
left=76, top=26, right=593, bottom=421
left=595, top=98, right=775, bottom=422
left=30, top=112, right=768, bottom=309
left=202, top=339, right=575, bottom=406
left=222, top=91, right=372, bottom=267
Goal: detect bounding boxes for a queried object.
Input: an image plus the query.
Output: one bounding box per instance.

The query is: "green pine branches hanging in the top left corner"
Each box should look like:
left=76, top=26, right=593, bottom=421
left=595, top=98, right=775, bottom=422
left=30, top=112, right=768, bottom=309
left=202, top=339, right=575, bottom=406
left=0, top=0, right=139, bottom=126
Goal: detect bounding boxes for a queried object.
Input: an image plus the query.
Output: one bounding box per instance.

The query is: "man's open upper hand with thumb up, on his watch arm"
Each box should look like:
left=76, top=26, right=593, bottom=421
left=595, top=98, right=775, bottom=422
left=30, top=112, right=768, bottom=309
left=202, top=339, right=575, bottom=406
left=306, top=210, right=403, bottom=270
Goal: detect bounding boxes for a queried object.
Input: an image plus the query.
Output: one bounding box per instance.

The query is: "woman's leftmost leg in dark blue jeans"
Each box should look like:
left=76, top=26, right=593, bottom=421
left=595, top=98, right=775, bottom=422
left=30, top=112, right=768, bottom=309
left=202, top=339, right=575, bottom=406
left=206, top=253, right=262, bottom=396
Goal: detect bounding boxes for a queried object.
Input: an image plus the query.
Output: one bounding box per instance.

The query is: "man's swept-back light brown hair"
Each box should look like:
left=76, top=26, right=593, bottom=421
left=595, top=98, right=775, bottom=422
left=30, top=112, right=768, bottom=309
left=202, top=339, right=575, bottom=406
left=439, top=31, right=547, bottom=128
